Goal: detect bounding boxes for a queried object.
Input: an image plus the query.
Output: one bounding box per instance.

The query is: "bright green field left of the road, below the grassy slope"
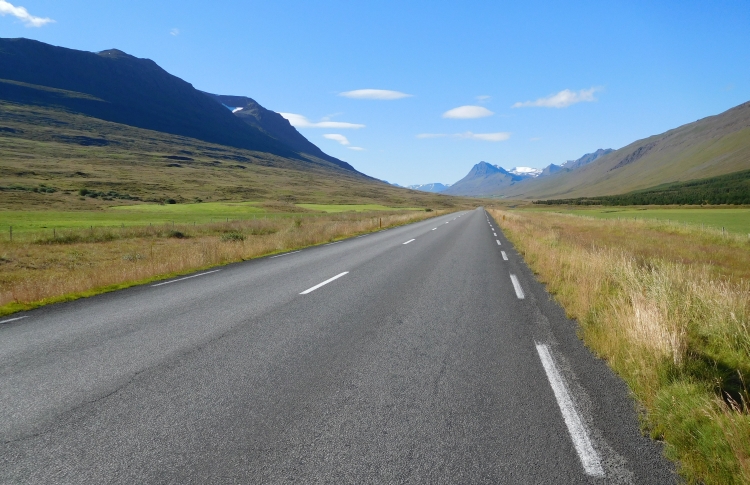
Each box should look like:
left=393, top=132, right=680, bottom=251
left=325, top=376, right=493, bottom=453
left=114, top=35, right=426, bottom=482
left=0, top=202, right=422, bottom=239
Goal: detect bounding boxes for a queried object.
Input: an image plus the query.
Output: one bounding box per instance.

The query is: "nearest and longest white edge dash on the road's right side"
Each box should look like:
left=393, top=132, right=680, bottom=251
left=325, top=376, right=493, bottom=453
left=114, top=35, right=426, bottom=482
left=536, top=344, right=604, bottom=477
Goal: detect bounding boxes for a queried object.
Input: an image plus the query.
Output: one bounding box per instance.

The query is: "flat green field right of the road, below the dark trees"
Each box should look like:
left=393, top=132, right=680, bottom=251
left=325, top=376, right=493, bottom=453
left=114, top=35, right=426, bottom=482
left=541, top=207, right=750, bottom=234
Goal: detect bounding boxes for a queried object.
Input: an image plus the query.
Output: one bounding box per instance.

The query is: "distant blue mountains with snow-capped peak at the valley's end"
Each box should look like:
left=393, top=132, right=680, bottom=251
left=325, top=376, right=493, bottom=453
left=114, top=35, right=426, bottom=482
left=443, top=148, right=613, bottom=197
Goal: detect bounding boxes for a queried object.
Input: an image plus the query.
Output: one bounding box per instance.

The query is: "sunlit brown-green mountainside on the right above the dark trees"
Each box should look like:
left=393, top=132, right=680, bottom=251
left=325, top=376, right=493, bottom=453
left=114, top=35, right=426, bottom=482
left=502, top=102, right=750, bottom=199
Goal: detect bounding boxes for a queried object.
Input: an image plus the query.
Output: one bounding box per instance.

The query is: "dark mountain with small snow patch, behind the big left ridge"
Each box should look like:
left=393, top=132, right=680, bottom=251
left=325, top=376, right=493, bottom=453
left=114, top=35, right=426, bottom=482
left=203, top=93, right=354, bottom=170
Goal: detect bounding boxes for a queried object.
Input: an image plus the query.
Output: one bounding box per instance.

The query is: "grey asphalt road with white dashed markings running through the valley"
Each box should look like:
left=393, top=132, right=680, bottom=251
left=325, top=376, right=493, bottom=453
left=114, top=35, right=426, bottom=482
left=0, top=208, right=676, bottom=484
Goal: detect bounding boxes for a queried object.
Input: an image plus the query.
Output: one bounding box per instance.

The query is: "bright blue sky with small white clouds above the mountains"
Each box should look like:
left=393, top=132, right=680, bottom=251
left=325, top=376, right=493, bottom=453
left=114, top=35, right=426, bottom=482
left=0, top=0, right=750, bottom=185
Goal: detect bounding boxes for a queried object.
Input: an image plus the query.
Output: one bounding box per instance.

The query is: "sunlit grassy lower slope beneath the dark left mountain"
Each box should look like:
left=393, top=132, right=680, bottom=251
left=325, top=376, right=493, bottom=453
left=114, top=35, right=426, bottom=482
left=0, top=102, right=468, bottom=210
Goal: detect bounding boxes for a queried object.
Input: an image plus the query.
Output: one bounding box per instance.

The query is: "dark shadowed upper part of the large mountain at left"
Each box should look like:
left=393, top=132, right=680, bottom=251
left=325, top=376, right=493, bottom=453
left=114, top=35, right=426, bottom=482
left=0, top=35, right=354, bottom=170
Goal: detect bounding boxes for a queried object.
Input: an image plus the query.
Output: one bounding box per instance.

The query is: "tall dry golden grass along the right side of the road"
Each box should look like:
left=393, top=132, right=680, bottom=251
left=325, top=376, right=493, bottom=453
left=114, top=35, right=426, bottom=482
left=490, top=210, right=750, bottom=484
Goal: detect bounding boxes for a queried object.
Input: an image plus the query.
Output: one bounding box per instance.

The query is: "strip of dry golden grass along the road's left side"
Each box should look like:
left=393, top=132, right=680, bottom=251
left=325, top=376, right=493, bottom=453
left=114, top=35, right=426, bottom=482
left=0, top=211, right=438, bottom=315
